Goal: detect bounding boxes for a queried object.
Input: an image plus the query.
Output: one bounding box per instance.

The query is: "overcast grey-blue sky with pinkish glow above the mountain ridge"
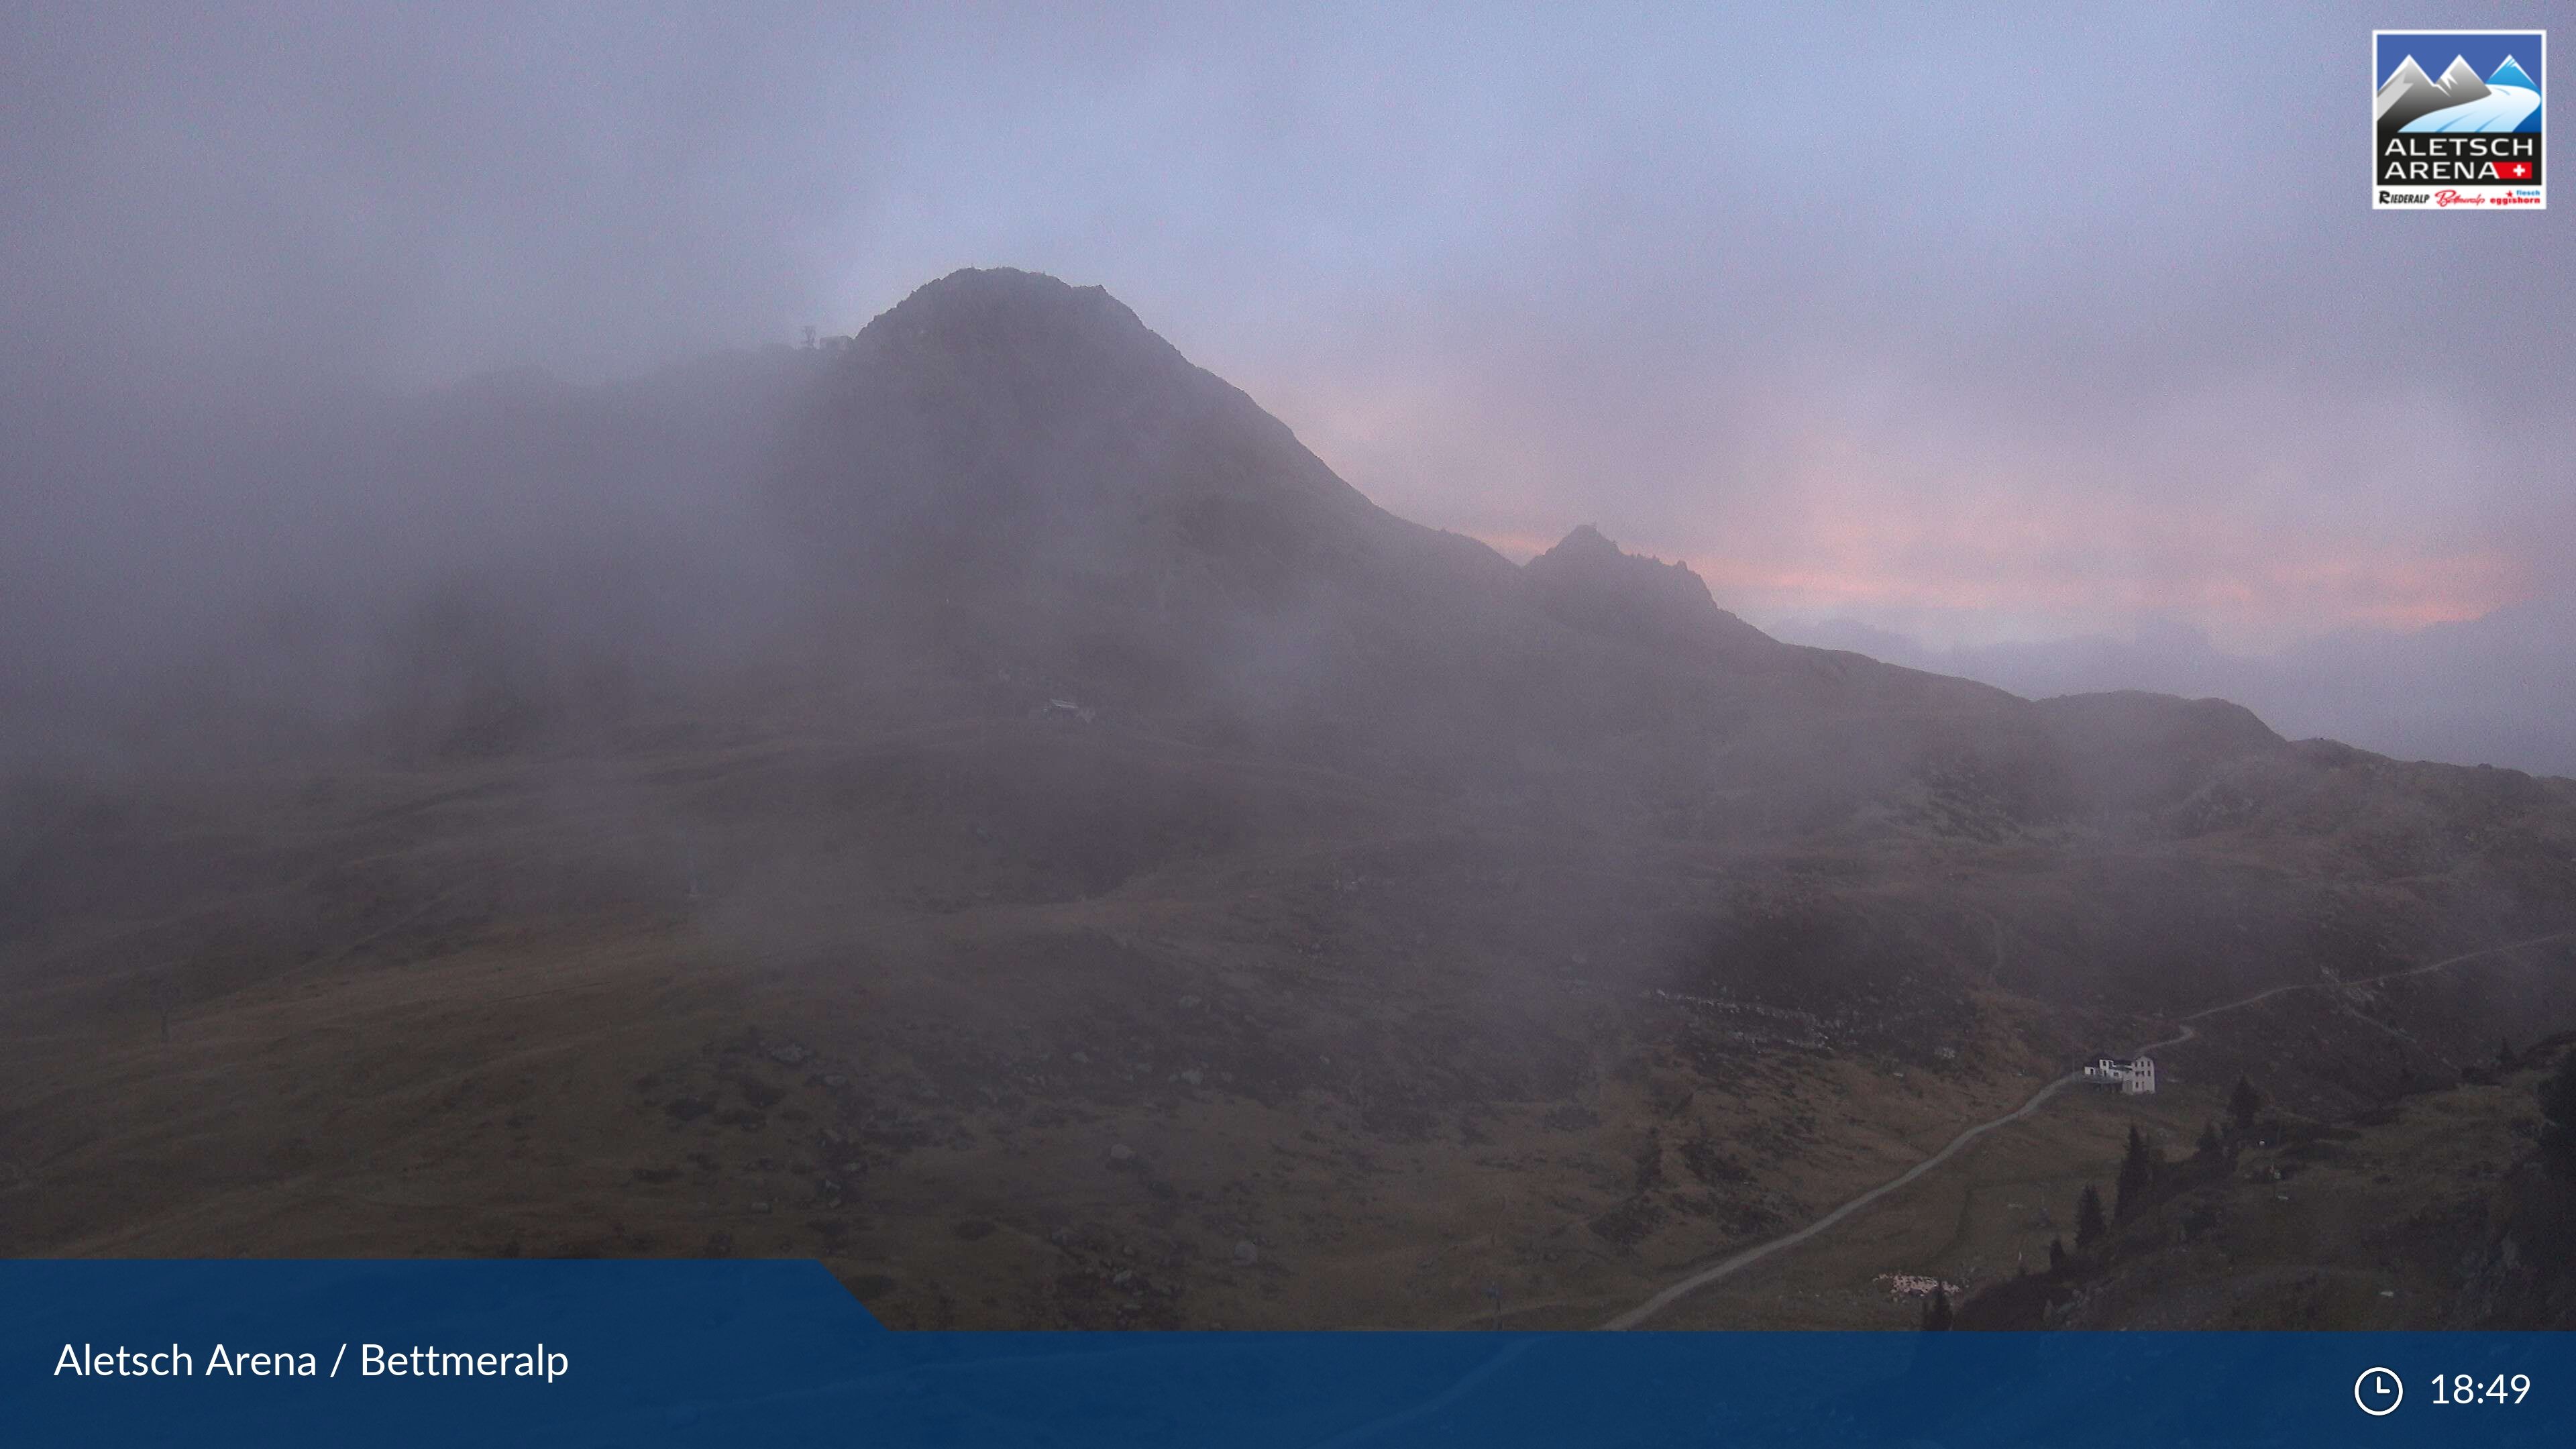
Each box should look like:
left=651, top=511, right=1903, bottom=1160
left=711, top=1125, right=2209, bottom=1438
left=0, top=0, right=2576, bottom=686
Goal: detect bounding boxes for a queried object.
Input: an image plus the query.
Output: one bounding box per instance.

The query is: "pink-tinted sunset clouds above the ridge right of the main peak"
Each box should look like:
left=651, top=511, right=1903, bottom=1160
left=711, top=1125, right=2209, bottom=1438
left=1308, top=361, right=2548, bottom=647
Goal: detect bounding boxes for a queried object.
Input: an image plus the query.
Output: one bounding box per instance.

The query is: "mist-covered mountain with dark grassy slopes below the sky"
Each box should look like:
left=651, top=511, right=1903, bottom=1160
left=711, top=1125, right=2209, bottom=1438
left=0, top=271, right=2576, bottom=1328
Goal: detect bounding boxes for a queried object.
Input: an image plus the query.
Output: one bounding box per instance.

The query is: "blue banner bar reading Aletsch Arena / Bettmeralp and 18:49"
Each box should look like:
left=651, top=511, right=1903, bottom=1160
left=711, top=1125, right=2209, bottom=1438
left=0, top=1260, right=2576, bottom=1446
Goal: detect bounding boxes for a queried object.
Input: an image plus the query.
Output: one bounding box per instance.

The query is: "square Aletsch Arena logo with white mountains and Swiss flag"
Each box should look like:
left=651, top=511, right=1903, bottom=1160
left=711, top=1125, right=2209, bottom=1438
left=2370, top=31, right=2548, bottom=211
